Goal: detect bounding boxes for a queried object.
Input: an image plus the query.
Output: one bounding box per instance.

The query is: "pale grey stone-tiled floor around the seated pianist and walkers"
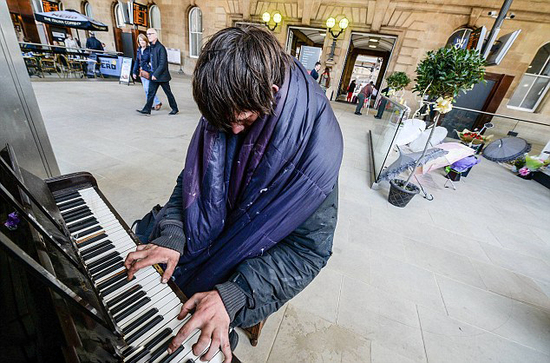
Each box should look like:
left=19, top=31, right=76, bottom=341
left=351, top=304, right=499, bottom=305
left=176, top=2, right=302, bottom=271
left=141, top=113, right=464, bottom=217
left=33, top=78, right=550, bottom=363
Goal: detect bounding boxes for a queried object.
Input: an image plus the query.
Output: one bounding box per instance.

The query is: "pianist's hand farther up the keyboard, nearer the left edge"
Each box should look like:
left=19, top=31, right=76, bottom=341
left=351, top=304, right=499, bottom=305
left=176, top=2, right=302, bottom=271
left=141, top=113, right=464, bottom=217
left=124, top=244, right=180, bottom=284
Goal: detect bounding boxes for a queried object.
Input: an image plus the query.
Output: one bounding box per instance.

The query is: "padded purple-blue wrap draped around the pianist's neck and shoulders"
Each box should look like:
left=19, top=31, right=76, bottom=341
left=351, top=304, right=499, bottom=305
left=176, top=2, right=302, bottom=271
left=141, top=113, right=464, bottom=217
left=176, top=61, right=343, bottom=296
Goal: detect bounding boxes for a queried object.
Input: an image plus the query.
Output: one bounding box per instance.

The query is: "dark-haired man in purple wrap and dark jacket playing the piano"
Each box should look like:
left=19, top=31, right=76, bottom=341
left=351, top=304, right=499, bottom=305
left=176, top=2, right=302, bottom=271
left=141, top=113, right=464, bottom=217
left=125, top=27, right=343, bottom=362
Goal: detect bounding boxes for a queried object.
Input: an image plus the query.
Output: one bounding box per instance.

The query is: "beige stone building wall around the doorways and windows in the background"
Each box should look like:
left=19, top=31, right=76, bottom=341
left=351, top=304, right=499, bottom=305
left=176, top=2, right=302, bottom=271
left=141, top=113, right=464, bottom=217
left=55, top=0, right=550, bottom=129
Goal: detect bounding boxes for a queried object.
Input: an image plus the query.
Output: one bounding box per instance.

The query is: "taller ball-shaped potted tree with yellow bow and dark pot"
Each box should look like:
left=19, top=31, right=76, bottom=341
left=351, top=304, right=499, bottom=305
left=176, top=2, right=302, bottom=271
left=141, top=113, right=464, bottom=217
left=388, top=46, right=485, bottom=207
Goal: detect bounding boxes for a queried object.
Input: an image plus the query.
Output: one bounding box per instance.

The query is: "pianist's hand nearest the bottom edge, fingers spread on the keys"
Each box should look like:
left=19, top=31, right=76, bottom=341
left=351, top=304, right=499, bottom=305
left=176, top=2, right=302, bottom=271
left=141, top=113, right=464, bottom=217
left=168, top=290, right=232, bottom=363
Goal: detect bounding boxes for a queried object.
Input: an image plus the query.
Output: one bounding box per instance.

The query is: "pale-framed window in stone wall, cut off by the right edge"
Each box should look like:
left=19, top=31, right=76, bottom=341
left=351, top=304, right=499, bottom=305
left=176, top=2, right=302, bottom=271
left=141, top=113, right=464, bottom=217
left=508, top=43, right=550, bottom=112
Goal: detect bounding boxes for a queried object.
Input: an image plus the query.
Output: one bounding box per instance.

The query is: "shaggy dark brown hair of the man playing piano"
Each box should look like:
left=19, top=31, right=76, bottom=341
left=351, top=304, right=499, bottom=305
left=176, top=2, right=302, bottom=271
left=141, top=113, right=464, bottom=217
left=193, top=26, right=292, bottom=130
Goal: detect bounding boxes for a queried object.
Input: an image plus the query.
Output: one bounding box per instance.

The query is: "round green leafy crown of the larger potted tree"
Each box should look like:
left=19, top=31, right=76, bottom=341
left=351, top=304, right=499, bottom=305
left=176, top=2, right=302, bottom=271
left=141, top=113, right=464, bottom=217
left=413, top=47, right=485, bottom=98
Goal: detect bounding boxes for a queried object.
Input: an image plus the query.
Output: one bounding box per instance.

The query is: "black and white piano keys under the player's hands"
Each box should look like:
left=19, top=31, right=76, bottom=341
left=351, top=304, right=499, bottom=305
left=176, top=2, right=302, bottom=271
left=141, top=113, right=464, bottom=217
left=55, top=188, right=224, bottom=363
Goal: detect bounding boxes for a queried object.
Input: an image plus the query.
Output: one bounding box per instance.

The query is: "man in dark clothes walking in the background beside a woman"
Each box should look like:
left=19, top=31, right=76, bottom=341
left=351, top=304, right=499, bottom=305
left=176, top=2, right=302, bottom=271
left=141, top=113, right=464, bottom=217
left=136, top=28, right=179, bottom=115
